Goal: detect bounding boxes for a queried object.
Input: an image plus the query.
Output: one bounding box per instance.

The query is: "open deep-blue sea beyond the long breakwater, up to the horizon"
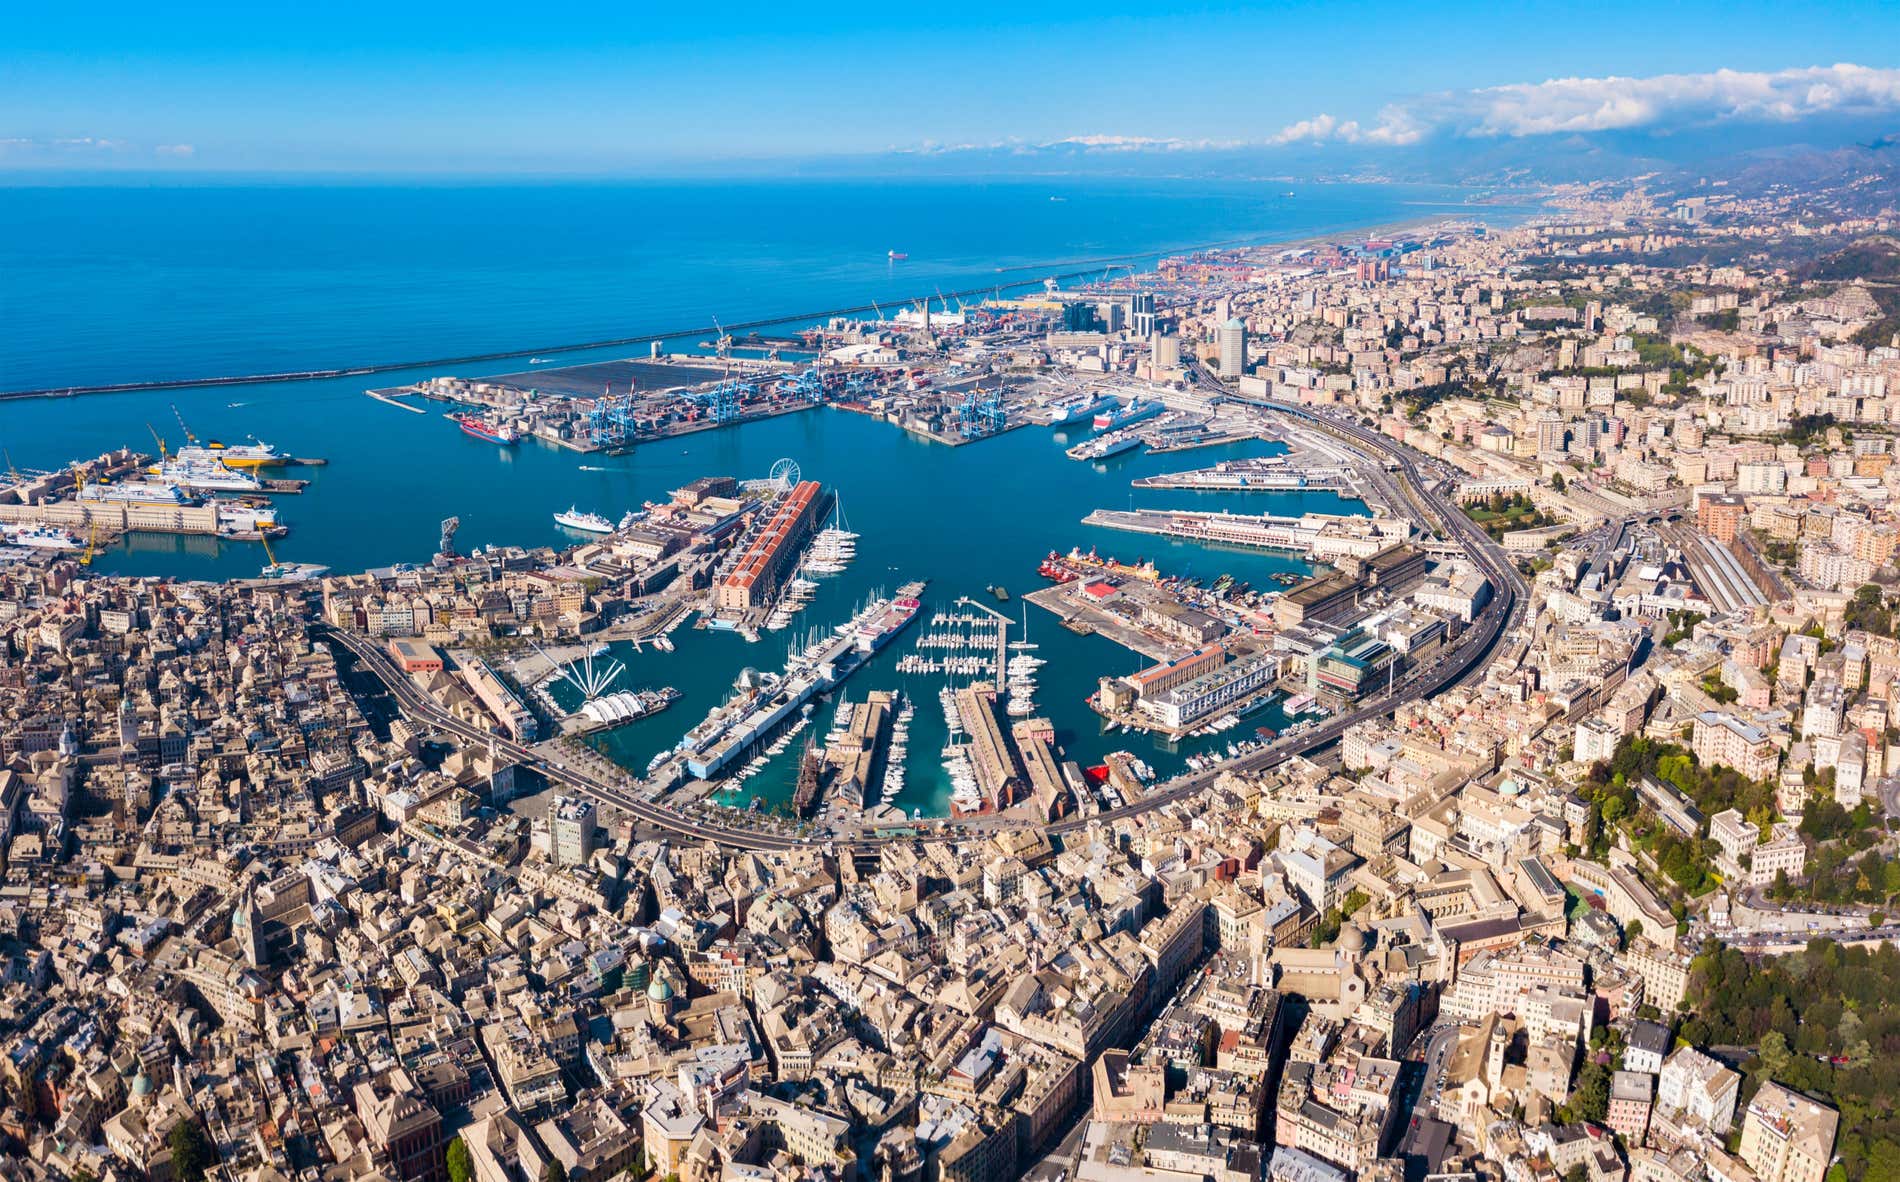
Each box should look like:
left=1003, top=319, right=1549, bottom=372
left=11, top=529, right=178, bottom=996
left=0, top=179, right=1497, bottom=391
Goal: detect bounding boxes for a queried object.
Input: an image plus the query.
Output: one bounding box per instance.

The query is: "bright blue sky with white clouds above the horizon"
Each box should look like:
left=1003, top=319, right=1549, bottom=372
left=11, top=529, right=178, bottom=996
left=11, top=0, right=1900, bottom=173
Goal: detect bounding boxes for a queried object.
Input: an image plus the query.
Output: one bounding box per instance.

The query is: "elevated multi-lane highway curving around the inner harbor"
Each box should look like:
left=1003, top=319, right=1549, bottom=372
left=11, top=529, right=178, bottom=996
left=330, top=387, right=1530, bottom=849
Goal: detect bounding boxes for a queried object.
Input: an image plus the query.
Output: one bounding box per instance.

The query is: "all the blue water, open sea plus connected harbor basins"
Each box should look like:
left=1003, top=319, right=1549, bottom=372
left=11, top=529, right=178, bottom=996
left=0, top=181, right=1497, bottom=813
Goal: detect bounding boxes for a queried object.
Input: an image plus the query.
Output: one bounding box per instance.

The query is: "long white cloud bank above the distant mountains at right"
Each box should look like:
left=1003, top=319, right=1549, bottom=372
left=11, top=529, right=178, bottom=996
left=1271, top=63, right=1900, bottom=144
